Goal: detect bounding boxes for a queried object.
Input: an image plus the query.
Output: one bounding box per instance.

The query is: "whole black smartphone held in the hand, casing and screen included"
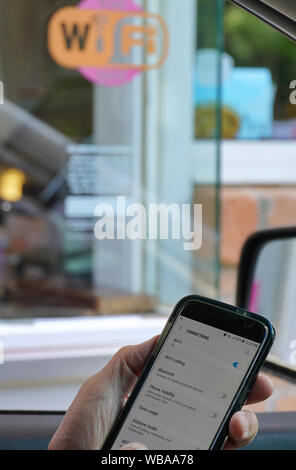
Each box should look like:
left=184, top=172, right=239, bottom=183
left=103, top=295, right=275, bottom=450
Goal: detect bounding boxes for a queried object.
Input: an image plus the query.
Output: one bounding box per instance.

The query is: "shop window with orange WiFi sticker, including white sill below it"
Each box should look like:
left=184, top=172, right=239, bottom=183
left=0, top=0, right=224, bottom=409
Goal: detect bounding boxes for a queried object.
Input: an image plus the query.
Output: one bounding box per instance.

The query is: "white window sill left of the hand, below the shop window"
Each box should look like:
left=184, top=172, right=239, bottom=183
left=0, top=314, right=167, bottom=411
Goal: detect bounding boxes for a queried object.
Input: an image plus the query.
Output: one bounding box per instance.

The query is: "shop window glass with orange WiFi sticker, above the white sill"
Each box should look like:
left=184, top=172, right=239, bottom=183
left=0, top=0, right=223, bottom=326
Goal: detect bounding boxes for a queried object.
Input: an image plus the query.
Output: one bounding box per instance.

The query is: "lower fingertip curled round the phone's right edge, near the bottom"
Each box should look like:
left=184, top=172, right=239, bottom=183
left=224, top=411, right=259, bottom=450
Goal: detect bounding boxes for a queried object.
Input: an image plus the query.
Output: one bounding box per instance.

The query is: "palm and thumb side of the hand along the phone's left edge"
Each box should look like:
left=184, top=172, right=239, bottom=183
left=50, top=336, right=158, bottom=450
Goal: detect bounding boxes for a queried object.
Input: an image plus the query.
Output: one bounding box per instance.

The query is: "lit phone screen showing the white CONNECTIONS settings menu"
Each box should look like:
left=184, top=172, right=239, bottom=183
left=112, top=314, right=260, bottom=450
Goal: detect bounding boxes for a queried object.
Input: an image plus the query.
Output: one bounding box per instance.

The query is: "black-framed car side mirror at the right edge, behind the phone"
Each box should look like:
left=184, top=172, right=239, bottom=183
left=236, top=227, right=296, bottom=382
